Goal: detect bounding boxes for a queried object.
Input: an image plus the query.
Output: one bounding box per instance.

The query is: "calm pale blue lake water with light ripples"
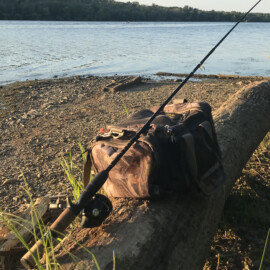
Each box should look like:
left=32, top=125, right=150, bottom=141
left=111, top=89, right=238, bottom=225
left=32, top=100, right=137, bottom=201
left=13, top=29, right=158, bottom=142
left=0, top=21, right=270, bottom=84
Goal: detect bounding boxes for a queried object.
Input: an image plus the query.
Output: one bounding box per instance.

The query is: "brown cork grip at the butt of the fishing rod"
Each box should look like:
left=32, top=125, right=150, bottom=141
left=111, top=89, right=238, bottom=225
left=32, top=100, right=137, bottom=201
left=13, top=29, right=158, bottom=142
left=21, top=208, right=77, bottom=269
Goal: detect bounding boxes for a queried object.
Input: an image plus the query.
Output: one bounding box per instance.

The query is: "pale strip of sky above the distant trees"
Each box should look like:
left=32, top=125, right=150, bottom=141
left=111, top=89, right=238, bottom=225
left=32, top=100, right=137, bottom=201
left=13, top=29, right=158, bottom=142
left=116, top=0, right=270, bottom=13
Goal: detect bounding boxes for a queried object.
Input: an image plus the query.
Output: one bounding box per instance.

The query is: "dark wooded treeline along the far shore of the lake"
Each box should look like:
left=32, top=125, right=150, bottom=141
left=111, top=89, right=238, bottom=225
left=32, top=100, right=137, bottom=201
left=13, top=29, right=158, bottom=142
left=0, top=0, right=270, bottom=22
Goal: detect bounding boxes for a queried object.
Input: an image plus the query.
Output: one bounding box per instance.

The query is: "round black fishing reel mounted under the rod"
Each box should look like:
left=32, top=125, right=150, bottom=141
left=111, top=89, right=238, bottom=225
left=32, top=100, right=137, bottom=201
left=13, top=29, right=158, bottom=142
left=81, top=194, right=112, bottom=228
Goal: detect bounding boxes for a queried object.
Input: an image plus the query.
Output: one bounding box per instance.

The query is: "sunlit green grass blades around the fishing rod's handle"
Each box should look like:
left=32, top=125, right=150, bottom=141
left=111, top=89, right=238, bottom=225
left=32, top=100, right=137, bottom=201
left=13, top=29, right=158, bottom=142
left=0, top=144, right=100, bottom=270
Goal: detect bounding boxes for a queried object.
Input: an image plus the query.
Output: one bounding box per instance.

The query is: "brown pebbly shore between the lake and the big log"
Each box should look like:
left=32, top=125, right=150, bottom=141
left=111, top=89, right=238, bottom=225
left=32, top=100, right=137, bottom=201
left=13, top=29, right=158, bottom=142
left=0, top=77, right=269, bottom=269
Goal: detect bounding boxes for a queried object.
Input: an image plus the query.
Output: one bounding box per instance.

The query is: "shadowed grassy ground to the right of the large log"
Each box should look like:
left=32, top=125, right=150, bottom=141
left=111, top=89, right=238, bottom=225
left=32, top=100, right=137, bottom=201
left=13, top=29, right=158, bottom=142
left=204, top=132, right=270, bottom=270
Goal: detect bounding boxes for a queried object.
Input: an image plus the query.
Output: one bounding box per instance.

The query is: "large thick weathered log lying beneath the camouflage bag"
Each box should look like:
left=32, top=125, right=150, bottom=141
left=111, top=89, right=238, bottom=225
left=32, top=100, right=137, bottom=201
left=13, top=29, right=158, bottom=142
left=54, top=81, right=270, bottom=270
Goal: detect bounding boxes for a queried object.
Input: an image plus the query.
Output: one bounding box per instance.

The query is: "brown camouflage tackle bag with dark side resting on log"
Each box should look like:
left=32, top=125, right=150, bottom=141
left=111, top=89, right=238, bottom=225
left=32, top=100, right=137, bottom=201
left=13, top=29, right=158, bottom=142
left=84, top=102, right=225, bottom=198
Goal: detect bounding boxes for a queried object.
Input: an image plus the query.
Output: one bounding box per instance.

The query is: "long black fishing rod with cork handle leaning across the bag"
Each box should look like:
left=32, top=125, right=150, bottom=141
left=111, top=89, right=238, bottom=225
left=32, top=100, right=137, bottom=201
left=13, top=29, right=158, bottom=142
left=21, top=0, right=262, bottom=267
